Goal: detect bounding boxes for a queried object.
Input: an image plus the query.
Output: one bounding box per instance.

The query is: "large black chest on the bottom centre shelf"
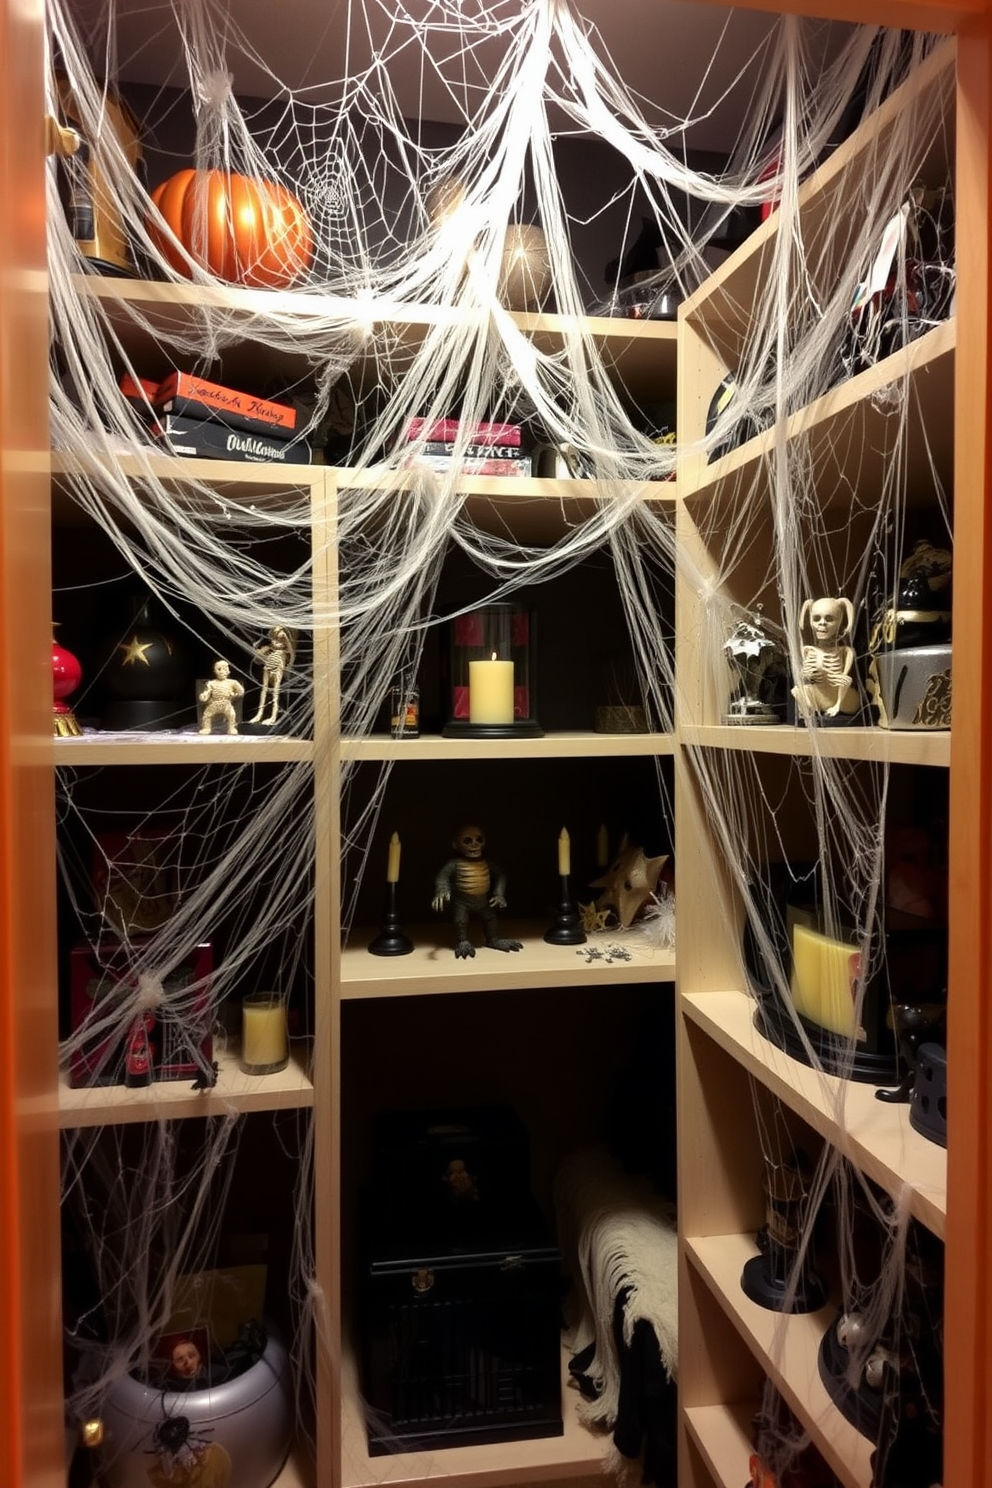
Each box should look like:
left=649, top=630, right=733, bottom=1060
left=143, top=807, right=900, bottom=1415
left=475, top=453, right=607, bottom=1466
left=363, top=1201, right=562, bottom=1457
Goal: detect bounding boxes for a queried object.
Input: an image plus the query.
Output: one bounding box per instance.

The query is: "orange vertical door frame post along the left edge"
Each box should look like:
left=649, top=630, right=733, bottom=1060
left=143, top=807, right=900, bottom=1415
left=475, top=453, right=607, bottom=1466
left=0, top=0, right=65, bottom=1488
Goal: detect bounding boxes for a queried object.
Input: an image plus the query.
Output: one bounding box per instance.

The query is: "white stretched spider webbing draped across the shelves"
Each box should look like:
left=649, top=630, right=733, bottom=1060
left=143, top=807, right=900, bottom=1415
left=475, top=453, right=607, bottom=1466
left=49, top=0, right=950, bottom=1476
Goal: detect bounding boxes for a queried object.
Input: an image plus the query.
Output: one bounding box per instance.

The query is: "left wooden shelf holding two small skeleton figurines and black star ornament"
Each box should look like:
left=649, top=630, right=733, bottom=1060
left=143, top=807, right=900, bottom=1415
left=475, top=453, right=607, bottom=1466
left=55, top=729, right=314, bottom=768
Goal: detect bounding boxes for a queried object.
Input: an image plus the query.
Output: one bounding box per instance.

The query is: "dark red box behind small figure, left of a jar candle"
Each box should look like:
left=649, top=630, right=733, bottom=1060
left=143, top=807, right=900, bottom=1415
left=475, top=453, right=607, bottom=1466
left=68, top=940, right=214, bottom=1088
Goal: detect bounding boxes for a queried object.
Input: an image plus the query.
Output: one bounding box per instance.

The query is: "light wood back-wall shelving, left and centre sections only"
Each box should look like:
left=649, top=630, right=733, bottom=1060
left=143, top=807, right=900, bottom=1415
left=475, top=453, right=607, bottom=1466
left=54, top=255, right=677, bottom=1488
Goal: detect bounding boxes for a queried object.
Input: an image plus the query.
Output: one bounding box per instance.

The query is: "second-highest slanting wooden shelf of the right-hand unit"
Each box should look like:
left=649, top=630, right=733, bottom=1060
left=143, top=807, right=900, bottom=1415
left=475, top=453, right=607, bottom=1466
left=681, top=320, right=958, bottom=506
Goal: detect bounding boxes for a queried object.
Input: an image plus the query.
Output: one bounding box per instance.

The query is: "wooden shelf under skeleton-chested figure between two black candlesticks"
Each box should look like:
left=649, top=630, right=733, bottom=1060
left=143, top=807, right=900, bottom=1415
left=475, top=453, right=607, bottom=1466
left=341, top=920, right=675, bottom=998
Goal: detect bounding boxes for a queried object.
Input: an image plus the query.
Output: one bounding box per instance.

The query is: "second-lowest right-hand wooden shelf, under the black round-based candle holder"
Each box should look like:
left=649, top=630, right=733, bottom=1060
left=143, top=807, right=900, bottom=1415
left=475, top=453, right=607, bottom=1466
left=684, top=1235, right=875, bottom=1488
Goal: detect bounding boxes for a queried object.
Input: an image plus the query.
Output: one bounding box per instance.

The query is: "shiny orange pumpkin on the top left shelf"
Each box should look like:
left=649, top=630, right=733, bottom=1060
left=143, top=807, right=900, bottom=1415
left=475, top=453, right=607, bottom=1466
left=149, top=170, right=314, bottom=289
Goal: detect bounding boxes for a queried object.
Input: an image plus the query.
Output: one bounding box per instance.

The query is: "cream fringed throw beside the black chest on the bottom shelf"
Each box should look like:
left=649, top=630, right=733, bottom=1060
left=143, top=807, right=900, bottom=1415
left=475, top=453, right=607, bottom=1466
left=555, top=1147, right=678, bottom=1426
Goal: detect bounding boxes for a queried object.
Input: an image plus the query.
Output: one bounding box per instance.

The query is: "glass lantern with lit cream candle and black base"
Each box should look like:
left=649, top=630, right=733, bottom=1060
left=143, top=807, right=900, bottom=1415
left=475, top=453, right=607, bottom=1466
left=442, top=603, right=544, bottom=738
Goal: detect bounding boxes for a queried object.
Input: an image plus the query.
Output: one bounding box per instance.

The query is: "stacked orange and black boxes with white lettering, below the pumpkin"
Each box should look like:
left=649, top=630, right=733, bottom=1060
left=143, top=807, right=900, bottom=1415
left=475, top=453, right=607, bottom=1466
left=120, top=372, right=312, bottom=464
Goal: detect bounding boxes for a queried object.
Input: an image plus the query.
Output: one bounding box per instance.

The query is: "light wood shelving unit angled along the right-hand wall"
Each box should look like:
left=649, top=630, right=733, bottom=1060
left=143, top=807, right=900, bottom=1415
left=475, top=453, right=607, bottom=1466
left=675, top=31, right=958, bottom=1488
